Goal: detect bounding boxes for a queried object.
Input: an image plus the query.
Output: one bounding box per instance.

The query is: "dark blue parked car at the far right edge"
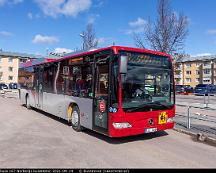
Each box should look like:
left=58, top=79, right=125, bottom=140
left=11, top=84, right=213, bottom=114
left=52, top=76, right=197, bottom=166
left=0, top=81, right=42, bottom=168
left=194, top=84, right=216, bottom=95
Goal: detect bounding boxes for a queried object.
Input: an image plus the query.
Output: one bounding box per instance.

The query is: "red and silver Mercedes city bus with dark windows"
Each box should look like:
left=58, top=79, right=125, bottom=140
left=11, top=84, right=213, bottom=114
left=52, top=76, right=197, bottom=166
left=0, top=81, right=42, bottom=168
left=19, top=46, right=175, bottom=137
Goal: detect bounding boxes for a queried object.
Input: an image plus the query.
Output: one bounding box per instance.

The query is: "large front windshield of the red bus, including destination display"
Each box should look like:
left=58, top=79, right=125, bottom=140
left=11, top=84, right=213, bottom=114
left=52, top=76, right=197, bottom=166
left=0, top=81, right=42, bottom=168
left=122, top=50, right=174, bottom=111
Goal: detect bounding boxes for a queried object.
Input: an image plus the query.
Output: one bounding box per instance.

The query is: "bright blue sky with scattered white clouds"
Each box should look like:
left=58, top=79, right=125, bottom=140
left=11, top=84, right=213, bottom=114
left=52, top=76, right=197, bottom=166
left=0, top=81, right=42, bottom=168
left=0, top=0, right=216, bottom=56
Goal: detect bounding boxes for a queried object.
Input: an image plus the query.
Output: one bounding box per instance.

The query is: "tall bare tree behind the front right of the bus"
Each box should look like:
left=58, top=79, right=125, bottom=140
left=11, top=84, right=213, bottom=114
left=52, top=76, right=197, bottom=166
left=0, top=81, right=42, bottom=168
left=134, top=0, right=188, bottom=55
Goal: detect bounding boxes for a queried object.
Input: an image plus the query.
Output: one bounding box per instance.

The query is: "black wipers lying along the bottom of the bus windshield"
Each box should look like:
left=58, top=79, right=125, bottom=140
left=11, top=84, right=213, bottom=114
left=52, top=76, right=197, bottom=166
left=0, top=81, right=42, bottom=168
left=127, top=101, right=171, bottom=112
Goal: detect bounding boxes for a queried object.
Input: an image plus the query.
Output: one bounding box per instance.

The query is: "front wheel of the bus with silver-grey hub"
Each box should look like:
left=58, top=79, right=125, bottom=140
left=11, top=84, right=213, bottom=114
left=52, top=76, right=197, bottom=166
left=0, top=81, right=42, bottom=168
left=71, top=106, right=82, bottom=132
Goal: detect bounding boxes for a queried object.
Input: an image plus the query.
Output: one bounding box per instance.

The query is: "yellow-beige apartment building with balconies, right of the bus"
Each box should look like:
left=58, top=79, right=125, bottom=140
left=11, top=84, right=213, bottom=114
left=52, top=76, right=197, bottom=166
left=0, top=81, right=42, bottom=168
left=175, top=55, right=216, bottom=87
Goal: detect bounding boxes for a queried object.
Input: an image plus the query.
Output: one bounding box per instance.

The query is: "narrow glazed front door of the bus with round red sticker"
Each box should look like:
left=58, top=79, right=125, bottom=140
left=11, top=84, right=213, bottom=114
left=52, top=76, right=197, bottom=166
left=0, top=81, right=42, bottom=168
left=93, top=63, right=109, bottom=134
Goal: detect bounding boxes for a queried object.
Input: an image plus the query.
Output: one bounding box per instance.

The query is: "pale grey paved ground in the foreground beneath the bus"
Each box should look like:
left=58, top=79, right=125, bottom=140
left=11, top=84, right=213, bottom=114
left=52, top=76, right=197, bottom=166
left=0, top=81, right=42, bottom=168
left=0, top=97, right=216, bottom=168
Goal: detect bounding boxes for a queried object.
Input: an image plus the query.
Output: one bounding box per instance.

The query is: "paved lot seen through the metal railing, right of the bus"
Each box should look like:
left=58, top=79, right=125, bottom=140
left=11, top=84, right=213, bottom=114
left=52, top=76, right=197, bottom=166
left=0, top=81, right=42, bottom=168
left=175, top=95, right=216, bottom=140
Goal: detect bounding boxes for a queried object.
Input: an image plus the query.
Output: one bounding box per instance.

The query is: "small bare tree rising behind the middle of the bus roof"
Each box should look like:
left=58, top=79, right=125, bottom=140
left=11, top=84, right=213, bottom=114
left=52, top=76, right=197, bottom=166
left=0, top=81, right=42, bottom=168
left=80, top=23, right=98, bottom=50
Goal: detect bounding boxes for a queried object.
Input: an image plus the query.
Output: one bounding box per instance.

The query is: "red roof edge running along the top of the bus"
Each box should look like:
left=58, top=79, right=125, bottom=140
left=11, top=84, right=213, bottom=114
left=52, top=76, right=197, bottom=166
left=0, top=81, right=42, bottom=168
left=21, top=46, right=170, bottom=68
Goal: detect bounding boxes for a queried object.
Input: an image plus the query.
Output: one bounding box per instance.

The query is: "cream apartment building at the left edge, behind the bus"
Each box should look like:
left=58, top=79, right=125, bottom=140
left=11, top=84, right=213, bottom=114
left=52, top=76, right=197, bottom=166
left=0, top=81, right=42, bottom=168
left=0, top=51, right=36, bottom=84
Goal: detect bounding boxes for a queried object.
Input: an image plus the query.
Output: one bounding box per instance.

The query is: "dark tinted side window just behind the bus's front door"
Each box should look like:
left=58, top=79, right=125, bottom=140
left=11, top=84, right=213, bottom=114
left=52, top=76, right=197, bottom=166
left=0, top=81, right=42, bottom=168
left=56, top=57, right=93, bottom=98
